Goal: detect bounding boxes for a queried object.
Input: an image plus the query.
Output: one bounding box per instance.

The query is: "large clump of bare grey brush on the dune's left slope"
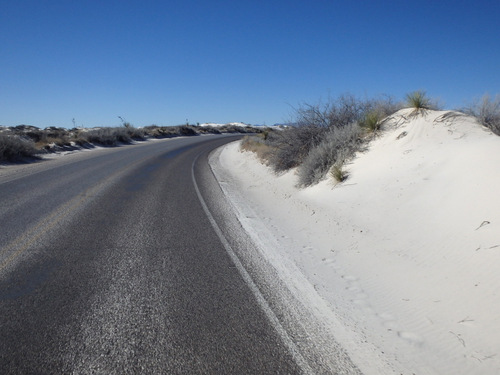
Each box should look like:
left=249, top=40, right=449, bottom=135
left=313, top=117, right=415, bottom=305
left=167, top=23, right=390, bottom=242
left=265, top=95, right=401, bottom=186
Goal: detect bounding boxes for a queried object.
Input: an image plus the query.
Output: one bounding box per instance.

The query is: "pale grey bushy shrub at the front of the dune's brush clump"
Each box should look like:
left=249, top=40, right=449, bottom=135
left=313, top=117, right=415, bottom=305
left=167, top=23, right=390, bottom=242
left=298, top=123, right=361, bottom=186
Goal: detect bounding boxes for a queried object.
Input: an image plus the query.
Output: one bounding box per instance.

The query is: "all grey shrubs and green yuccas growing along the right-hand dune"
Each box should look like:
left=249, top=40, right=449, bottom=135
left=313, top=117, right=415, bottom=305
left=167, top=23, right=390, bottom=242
left=241, top=91, right=500, bottom=187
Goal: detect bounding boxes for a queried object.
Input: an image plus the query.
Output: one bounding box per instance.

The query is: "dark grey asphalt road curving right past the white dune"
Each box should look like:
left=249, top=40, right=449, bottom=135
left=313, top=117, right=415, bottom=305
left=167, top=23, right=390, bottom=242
left=0, top=136, right=309, bottom=374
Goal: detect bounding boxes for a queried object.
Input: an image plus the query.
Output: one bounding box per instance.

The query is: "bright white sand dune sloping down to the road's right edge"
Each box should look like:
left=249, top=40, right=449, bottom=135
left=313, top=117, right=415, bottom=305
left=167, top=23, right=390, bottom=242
left=211, top=110, right=500, bottom=374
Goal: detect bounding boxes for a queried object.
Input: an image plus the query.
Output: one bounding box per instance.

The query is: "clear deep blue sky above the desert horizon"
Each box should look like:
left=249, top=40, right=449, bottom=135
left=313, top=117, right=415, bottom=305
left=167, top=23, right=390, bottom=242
left=0, top=0, right=500, bottom=127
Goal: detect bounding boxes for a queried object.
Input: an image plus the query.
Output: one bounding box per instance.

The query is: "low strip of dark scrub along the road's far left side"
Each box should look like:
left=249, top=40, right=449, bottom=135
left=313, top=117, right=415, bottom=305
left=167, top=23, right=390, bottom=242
left=0, top=122, right=262, bottom=162
